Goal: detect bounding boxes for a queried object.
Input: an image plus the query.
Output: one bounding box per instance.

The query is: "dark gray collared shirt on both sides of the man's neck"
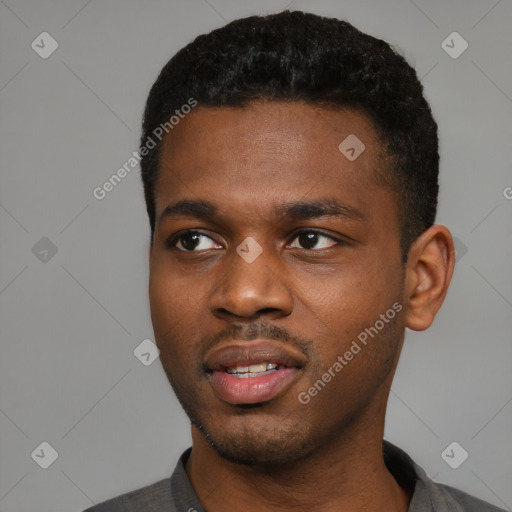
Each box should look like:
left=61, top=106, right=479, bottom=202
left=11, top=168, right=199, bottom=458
left=84, top=441, right=505, bottom=512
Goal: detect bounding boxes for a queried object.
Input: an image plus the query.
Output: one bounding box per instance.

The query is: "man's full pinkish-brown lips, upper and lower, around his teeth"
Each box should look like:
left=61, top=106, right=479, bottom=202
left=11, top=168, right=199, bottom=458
left=205, top=340, right=306, bottom=405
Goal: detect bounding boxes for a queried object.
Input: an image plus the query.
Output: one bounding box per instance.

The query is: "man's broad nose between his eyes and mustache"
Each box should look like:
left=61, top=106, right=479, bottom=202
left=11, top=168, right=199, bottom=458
left=210, top=243, right=293, bottom=320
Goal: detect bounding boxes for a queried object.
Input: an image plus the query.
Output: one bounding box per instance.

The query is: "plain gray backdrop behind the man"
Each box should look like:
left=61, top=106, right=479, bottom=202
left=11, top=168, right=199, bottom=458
left=0, top=0, right=512, bottom=512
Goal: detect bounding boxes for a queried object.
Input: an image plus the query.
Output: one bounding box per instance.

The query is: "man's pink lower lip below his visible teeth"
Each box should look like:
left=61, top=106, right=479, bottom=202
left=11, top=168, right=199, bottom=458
left=211, top=368, right=299, bottom=404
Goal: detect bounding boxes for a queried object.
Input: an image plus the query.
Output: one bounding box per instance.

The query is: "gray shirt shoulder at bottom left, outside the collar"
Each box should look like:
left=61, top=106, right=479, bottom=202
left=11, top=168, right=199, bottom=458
left=84, top=478, right=176, bottom=512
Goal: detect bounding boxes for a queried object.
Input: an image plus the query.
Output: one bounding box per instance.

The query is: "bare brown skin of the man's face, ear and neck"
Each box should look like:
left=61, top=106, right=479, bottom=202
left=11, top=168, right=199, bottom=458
left=149, top=102, right=455, bottom=512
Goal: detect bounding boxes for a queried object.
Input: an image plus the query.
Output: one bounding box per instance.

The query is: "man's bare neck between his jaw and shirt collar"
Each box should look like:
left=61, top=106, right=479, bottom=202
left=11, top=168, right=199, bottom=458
left=186, top=396, right=410, bottom=512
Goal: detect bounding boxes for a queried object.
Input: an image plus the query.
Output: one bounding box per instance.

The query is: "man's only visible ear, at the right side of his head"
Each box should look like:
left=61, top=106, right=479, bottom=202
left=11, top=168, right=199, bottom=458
left=404, top=225, right=455, bottom=331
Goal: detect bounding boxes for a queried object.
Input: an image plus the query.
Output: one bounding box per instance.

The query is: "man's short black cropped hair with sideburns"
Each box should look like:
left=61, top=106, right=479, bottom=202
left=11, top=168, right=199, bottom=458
left=141, top=11, right=439, bottom=260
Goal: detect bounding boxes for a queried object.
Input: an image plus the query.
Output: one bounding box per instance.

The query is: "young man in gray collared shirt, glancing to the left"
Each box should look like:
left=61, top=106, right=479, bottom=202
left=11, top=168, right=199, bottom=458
left=84, top=12, right=504, bottom=512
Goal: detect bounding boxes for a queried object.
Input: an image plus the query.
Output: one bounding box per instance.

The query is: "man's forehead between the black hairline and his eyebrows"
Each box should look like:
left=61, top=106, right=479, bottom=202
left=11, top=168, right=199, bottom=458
left=155, top=102, right=390, bottom=224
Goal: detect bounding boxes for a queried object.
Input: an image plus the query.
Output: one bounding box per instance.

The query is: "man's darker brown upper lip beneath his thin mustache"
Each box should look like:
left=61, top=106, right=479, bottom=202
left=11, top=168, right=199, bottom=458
left=205, top=340, right=306, bottom=371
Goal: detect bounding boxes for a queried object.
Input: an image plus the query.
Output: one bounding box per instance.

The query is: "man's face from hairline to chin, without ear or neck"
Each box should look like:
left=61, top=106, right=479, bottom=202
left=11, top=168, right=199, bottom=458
left=149, top=102, right=404, bottom=464
